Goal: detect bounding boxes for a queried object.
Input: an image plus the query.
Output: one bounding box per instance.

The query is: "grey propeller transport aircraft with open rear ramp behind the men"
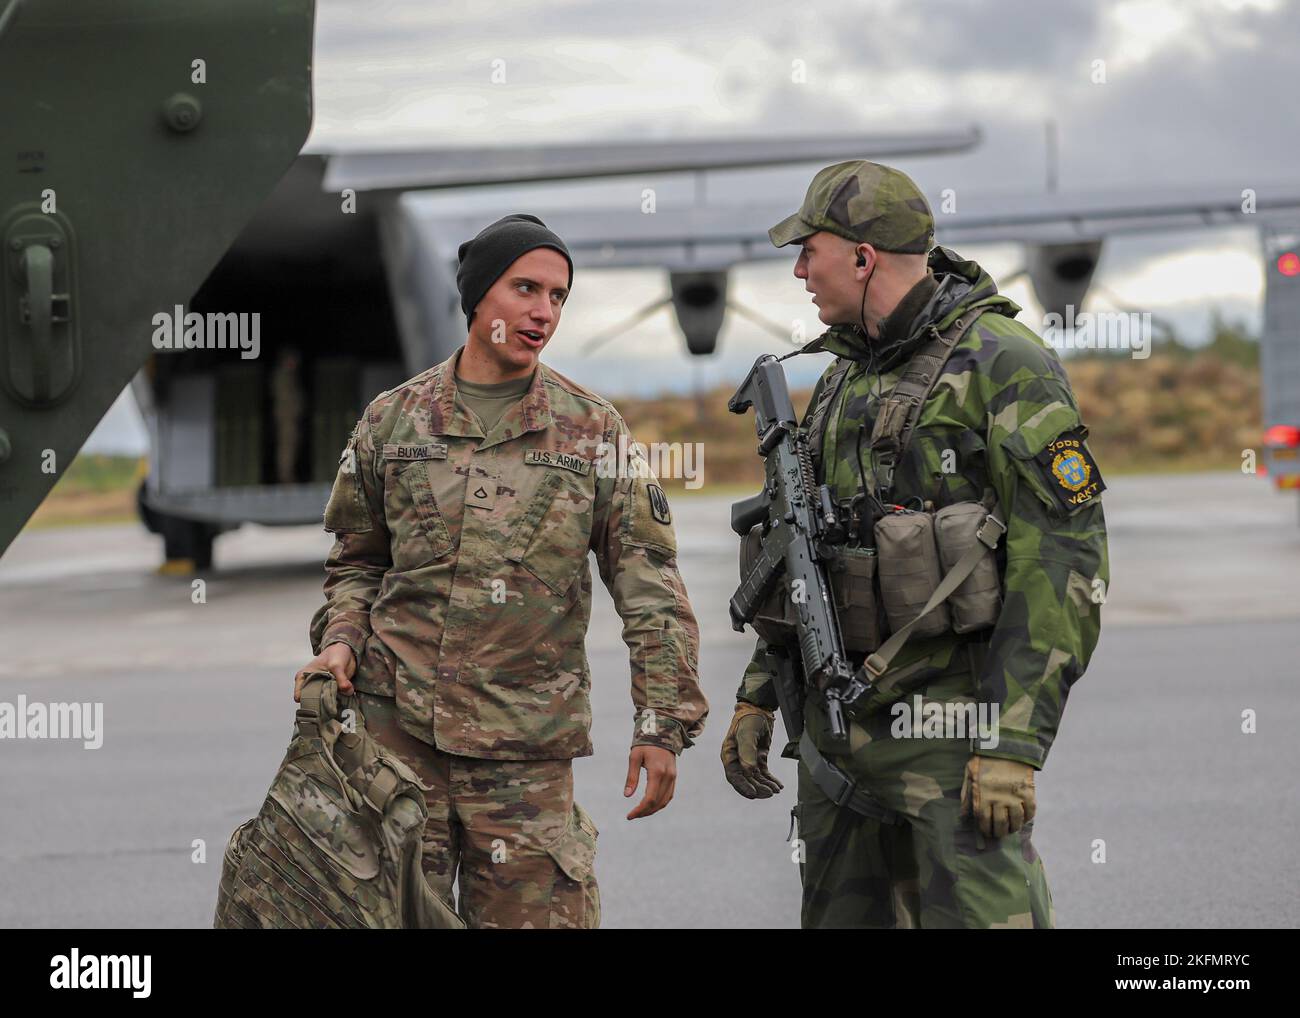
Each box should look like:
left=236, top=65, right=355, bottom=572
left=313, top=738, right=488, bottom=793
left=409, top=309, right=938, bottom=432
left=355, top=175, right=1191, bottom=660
left=133, top=154, right=1300, bottom=563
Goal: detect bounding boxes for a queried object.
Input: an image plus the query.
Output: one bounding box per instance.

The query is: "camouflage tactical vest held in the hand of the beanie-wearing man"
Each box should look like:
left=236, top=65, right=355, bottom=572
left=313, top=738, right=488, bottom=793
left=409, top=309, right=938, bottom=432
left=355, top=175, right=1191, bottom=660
left=213, top=672, right=464, bottom=930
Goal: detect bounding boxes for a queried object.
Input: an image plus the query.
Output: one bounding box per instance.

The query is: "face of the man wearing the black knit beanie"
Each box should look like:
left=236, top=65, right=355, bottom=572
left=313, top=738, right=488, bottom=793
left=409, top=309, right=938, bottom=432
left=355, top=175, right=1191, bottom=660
left=467, top=247, right=568, bottom=377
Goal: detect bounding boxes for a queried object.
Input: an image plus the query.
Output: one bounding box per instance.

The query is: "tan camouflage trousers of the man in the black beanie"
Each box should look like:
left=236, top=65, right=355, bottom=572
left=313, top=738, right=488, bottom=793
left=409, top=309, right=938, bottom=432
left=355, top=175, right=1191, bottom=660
left=358, top=693, right=601, bottom=928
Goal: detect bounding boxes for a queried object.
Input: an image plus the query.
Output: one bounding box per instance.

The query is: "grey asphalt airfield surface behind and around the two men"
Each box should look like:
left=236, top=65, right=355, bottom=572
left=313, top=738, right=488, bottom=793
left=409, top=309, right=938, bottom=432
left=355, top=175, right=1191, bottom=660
left=0, top=473, right=1300, bottom=928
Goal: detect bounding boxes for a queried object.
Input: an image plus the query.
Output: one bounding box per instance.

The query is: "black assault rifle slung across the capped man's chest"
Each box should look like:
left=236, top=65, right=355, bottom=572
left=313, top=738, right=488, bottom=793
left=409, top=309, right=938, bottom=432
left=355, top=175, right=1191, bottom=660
left=727, top=354, right=871, bottom=741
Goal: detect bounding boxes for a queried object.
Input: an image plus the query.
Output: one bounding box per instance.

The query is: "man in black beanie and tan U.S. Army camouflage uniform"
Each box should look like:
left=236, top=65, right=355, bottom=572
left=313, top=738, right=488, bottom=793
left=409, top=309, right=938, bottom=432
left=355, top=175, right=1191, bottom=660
left=295, top=216, right=707, bottom=927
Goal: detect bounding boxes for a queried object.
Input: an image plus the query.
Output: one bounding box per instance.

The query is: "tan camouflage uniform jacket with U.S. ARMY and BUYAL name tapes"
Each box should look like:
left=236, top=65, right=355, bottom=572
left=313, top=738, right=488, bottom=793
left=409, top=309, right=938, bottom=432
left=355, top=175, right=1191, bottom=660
left=311, top=351, right=709, bottom=759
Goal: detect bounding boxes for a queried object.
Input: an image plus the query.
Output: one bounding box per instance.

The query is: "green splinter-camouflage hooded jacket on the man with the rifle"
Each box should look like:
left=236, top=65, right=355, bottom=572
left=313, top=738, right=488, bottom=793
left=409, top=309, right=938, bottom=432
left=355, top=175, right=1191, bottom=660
left=738, top=247, right=1110, bottom=767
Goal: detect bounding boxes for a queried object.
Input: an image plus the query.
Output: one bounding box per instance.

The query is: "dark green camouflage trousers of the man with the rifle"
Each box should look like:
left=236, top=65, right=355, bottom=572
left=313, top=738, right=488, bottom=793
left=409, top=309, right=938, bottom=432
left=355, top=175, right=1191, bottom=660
left=794, top=675, right=1056, bottom=928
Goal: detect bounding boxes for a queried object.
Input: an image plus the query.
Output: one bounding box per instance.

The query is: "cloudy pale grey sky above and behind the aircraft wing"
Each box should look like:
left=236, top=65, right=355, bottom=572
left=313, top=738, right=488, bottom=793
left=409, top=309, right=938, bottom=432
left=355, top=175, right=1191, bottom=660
left=90, top=0, right=1300, bottom=449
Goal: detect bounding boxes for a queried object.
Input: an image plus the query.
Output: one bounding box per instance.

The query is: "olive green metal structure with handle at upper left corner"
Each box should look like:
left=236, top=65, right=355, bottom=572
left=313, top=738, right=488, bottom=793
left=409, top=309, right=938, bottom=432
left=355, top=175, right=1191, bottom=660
left=0, top=0, right=315, bottom=551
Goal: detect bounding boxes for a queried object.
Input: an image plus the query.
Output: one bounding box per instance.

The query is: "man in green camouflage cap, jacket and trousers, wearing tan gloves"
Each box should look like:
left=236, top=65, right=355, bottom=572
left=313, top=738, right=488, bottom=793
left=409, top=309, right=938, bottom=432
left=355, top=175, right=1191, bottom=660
left=723, top=160, right=1109, bottom=928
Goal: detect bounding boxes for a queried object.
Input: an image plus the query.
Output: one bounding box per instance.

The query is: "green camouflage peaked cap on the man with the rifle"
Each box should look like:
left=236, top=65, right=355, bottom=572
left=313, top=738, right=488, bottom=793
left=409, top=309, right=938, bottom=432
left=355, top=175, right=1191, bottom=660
left=767, top=159, right=935, bottom=255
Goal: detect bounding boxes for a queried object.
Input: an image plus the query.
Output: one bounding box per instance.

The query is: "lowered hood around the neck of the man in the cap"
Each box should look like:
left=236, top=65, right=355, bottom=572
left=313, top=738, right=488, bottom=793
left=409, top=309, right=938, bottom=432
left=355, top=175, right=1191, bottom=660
left=802, top=247, right=1021, bottom=372
